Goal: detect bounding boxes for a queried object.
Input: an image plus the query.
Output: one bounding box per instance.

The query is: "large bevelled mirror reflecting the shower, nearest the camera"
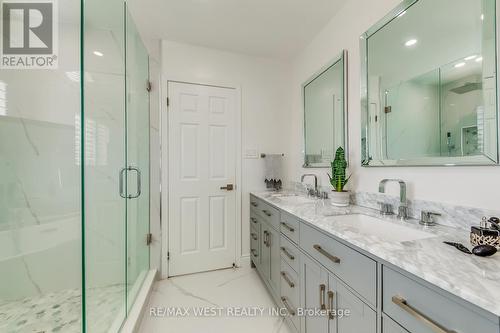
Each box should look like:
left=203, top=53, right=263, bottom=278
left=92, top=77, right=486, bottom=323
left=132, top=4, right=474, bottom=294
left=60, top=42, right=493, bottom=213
left=361, top=0, right=498, bottom=166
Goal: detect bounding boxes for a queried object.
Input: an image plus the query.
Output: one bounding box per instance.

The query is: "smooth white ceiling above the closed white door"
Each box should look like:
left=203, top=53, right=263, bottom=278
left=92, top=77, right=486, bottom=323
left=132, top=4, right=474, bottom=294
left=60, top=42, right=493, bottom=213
left=128, top=0, right=347, bottom=59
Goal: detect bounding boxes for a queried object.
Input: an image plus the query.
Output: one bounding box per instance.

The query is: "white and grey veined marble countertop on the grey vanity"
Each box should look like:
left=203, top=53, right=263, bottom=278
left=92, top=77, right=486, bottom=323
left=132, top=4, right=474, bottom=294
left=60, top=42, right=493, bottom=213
left=252, top=192, right=500, bottom=317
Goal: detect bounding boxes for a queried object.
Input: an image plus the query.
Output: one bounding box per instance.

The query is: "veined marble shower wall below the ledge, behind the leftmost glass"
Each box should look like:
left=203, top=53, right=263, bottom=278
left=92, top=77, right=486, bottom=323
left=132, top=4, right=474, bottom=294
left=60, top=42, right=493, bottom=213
left=0, top=115, right=81, bottom=303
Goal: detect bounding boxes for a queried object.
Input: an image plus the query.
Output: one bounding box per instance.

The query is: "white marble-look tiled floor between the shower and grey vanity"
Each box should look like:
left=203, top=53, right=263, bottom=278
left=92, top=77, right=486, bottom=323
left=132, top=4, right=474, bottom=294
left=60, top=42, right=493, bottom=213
left=139, top=267, right=292, bottom=333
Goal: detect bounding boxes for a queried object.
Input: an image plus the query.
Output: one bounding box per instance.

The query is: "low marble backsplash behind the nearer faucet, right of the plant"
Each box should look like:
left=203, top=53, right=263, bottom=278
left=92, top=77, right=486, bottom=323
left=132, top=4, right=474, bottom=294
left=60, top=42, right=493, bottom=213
left=351, top=192, right=500, bottom=230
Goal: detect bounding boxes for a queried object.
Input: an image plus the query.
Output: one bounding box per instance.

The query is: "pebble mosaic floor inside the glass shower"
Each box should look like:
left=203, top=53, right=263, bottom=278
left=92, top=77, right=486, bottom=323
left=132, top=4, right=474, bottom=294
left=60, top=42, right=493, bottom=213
left=0, top=285, right=124, bottom=333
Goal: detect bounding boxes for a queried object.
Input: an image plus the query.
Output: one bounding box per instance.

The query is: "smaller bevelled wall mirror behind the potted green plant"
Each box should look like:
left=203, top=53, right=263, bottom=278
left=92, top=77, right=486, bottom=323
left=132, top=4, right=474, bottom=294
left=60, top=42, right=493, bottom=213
left=302, top=51, right=347, bottom=168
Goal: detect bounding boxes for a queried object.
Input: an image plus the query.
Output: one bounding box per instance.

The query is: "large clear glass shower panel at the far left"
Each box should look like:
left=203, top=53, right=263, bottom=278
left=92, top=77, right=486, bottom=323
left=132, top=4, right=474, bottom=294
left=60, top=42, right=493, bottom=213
left=0, top=0, right=82, bottom=333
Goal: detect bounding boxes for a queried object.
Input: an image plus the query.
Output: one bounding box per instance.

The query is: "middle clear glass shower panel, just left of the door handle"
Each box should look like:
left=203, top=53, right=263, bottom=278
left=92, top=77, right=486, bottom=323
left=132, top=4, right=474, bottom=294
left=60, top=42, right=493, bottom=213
left=83, top=0, right=129, bottom=333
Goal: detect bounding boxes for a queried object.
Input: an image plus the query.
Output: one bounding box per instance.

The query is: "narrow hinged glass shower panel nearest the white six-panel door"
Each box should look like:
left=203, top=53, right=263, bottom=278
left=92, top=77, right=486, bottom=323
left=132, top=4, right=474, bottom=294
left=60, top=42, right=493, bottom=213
left=125, top=5, right=150, bottom=310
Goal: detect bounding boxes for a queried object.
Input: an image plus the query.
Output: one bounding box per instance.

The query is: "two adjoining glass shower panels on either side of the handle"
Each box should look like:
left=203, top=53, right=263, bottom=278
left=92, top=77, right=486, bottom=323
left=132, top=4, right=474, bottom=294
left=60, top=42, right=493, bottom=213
left=84, top=0, right=149, bottom=332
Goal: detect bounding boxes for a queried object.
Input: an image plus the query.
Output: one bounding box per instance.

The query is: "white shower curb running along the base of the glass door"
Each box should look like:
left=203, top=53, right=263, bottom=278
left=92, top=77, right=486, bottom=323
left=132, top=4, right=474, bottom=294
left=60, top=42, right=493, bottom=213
left=120, top=269, right=158, bottom=333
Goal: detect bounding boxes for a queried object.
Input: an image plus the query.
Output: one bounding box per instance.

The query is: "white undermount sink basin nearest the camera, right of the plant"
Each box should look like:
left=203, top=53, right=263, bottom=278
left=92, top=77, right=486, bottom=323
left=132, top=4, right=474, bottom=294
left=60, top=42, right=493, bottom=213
left=335, top=214, right=436, bottom=242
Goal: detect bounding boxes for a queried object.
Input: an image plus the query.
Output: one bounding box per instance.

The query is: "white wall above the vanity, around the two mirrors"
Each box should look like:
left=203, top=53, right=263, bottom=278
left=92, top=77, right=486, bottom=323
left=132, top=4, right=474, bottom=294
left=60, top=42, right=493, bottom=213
left=287, top=0, right=500, bottom=209
